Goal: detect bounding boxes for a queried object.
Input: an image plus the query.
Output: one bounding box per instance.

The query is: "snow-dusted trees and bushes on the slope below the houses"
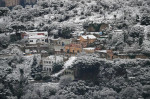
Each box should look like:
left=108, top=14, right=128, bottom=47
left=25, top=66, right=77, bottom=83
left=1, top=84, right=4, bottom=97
left=0, top=54, right=150, bottom=99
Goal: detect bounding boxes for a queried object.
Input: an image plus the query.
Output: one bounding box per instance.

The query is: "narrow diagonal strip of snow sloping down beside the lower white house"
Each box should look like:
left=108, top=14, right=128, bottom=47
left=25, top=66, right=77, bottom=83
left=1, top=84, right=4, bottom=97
left=52, top=56, right=77, bottom=77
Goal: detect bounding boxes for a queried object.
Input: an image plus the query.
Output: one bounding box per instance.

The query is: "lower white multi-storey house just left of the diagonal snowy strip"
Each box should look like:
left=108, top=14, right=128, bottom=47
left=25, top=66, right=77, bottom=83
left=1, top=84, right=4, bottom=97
left=42, top=55, right=63, bottom=73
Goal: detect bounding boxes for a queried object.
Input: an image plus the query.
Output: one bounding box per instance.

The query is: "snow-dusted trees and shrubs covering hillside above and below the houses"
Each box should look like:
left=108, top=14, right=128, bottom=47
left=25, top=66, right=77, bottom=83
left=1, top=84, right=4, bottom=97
left=0, top=0, right=150, bottom=99
